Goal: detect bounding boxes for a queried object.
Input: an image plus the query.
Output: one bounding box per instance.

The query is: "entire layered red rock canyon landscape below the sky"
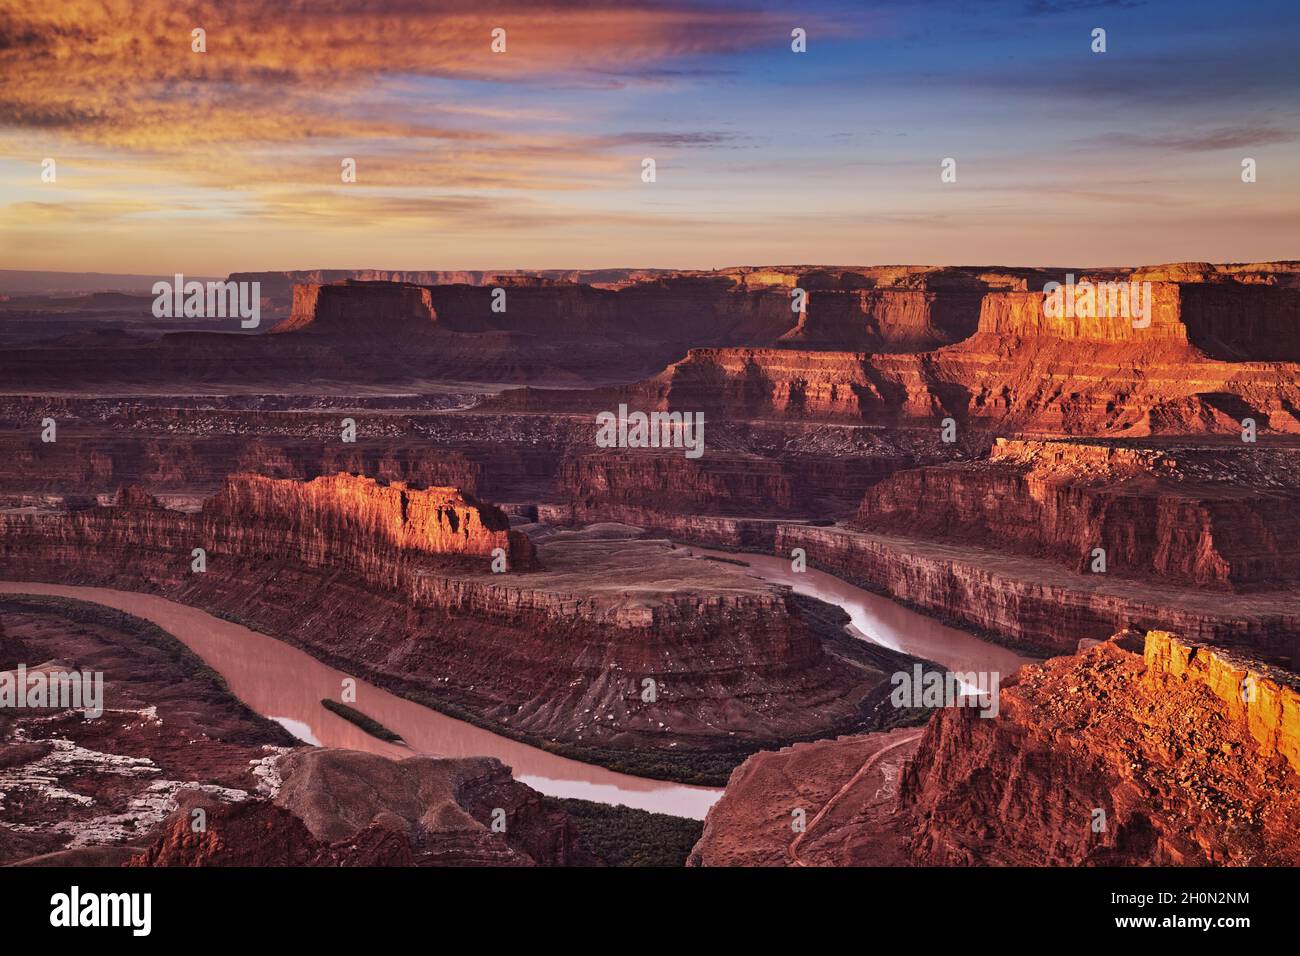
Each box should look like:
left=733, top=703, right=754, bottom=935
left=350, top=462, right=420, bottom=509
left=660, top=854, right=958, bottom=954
left=0, top=261, right=1300, bottom=866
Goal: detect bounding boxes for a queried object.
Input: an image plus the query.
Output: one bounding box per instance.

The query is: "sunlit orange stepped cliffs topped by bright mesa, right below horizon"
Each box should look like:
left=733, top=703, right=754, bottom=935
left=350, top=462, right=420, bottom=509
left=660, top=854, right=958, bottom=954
left=503, top=274, right=1300, bottom=436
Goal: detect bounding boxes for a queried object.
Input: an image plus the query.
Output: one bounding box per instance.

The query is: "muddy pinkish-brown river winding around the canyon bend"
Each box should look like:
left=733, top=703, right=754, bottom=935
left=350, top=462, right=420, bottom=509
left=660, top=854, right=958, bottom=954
left=0, top=548, right=1023, bottom=819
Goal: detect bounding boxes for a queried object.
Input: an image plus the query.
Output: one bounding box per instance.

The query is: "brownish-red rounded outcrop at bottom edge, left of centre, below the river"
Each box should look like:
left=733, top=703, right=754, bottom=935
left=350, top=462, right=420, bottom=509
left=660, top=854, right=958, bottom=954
left=127, top=748, right=601, bottom=866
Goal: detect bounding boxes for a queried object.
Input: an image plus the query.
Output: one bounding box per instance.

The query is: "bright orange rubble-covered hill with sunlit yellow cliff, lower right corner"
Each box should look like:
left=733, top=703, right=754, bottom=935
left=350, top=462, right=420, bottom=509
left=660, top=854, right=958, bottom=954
left=900, top=632, right=1300, bottom=866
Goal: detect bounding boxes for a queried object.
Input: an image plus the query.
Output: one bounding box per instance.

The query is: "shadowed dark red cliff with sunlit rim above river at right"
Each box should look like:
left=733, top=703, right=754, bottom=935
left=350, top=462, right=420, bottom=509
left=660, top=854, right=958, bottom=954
left=855, top=438, right=1300, bottom=591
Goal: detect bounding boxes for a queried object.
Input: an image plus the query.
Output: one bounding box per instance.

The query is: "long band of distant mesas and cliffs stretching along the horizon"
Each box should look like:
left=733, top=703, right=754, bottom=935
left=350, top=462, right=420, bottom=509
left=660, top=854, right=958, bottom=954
left=10, top=264, right=1300, bottom=392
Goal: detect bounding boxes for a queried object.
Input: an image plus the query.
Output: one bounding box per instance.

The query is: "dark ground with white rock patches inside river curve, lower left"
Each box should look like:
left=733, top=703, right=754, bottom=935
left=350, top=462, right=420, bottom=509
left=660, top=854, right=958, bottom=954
left=0, top=596, right=296, bottom=865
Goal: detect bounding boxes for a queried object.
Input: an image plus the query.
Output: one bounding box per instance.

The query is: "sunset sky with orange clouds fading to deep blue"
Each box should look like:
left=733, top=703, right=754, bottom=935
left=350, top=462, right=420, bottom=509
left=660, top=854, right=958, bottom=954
left=0, top=0, right=1300, bottom=276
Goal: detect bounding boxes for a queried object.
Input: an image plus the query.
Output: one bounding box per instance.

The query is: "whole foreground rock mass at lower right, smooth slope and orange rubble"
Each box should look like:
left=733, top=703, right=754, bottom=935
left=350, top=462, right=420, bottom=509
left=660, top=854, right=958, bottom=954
left=692, top=631, right=1300, bottom=866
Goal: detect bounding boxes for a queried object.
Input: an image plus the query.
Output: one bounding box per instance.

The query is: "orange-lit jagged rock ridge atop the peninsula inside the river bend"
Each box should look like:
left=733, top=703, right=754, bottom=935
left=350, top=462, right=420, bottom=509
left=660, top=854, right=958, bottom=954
left=203, top=473, right=537, bottom=571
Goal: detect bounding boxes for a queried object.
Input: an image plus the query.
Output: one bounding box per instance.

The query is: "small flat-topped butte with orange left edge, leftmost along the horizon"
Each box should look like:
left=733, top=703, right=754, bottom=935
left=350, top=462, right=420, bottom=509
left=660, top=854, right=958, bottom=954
left=270, top=280, right=438, bottom=339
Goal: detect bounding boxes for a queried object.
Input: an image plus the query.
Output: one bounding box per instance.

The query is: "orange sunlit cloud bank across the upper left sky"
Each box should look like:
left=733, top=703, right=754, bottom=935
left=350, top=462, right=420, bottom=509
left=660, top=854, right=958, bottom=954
left=0, top=0, right=787, bottom=150
